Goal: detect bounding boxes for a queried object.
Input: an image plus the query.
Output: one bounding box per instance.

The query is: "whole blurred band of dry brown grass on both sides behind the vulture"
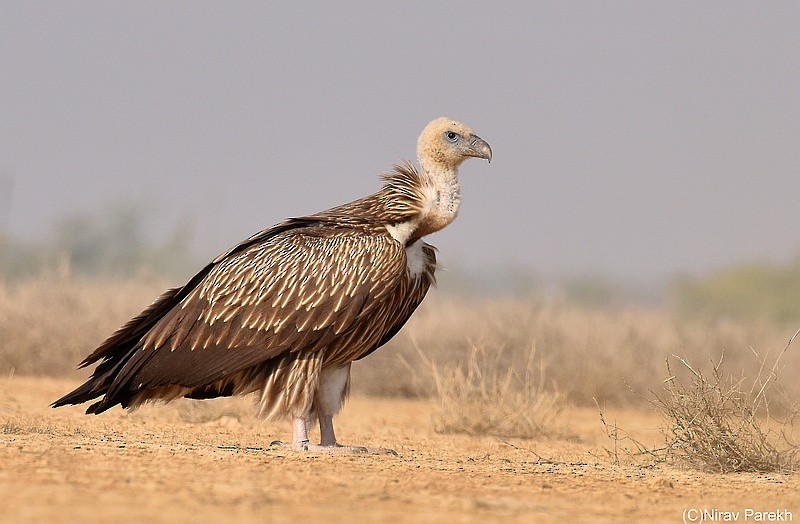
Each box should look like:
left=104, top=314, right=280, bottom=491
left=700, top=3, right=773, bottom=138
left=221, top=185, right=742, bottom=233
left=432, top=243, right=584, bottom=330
left=0, top=274, right=800, bottom=416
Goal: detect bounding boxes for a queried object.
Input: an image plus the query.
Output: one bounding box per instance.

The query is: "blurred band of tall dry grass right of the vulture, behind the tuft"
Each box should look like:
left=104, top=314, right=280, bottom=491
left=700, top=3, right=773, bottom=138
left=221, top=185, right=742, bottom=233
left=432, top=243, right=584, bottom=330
left=364, top=293, right=800, bottom=407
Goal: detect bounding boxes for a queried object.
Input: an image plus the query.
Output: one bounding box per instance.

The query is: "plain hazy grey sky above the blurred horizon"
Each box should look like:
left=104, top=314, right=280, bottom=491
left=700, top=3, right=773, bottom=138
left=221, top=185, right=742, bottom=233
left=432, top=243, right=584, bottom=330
left=0, top=0, right=800, bottom=280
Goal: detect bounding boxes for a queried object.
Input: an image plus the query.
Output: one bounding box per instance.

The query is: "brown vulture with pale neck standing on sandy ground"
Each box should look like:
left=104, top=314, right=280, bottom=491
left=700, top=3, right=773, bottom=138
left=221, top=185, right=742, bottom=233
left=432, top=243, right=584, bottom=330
left=52, top=117, right=492, bottom=452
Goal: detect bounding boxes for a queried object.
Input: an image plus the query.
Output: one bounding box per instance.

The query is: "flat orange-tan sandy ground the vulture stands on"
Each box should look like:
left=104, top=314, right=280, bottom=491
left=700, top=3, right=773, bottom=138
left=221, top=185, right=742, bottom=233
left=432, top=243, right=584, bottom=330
left=0, top=377, right=800, bottom=523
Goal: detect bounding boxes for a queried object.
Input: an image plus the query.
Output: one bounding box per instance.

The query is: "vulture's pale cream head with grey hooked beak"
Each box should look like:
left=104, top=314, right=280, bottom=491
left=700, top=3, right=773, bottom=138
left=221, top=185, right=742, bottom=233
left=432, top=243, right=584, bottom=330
left=417, top=116, right=492, bottom=171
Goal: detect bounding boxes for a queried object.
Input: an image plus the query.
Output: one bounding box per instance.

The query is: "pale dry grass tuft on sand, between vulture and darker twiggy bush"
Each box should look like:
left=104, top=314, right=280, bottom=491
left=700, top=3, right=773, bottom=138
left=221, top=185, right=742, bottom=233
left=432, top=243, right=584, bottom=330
left=428, top=344, right=564, bottom=438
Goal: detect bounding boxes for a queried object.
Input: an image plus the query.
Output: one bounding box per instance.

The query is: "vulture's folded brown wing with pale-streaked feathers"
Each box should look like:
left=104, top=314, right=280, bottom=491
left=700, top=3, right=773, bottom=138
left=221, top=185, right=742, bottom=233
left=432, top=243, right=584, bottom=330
left=101, top=226, right=408, bottom=398
